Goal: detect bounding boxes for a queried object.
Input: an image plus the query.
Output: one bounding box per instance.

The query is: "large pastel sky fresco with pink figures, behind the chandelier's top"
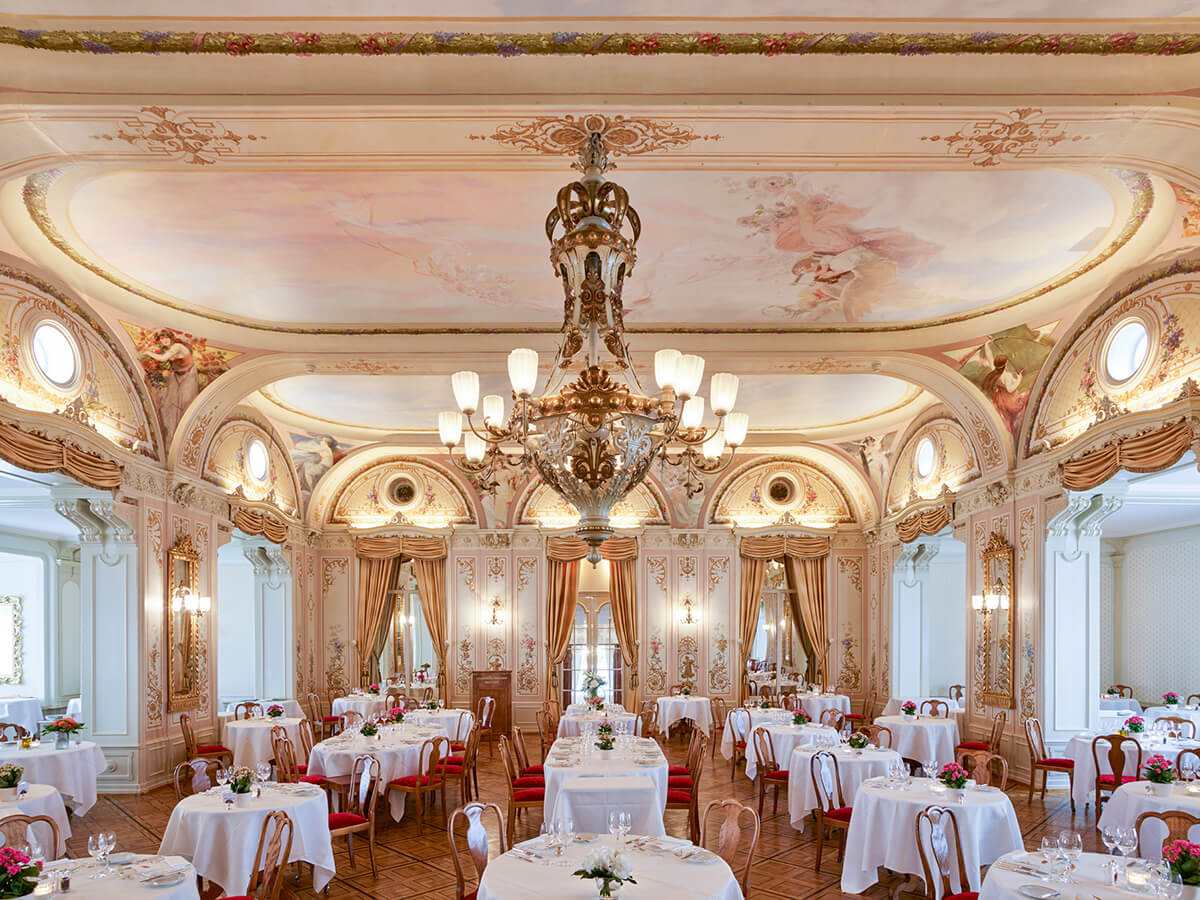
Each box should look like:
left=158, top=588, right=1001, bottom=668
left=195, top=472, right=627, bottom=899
left=64, top=166, right=1115, bottom=325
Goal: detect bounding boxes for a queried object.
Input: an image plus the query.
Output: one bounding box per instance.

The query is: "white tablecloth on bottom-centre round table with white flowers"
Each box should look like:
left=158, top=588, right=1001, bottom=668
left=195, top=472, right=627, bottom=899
left=479, top=836, right=742, bottom=900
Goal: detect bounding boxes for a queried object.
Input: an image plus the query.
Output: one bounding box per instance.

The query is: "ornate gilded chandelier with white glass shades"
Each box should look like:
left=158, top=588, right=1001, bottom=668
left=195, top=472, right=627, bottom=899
left=438, top=134, right=750, bottom=563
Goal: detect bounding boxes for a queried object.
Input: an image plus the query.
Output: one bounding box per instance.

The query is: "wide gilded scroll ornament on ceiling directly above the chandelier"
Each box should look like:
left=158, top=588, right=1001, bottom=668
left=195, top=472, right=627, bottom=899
left=469, top=113, right=721, bottom=157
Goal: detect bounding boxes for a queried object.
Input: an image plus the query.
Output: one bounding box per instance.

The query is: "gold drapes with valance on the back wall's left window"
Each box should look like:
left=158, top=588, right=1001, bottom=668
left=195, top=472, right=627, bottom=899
left=355, top=535, right=450, bottom=703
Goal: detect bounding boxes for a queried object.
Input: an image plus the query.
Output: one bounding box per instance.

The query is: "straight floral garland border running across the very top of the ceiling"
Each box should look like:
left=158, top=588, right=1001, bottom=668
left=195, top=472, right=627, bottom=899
left=0, top=26, right=1200, bottom=56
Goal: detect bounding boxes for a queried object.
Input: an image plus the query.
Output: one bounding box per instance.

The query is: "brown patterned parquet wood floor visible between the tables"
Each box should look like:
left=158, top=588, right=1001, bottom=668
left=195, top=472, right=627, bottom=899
left=68, top=739, right=1103, bottom=900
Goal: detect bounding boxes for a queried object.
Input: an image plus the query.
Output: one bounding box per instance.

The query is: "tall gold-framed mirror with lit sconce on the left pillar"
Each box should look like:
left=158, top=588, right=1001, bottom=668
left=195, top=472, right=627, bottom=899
left=163, top=534, right=200, bottom=713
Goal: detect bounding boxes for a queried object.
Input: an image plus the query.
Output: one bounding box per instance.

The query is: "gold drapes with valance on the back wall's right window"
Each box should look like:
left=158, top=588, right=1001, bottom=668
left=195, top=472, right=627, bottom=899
left=738, top=535, right=829, bottom=703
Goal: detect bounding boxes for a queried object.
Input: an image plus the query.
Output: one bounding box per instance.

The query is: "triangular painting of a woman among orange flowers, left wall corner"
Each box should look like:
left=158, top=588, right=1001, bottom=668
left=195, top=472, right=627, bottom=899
left=121, top=322, right=240, bottom=442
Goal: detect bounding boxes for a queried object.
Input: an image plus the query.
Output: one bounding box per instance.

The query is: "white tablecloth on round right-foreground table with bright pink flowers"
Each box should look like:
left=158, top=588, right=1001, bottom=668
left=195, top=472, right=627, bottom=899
left=841, top=779, right=1025, bottom=894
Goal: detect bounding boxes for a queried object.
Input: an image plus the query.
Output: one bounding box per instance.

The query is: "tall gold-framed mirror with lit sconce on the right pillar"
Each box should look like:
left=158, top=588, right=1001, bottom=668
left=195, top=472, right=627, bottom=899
left=978, top=532, right=1016, bottom=709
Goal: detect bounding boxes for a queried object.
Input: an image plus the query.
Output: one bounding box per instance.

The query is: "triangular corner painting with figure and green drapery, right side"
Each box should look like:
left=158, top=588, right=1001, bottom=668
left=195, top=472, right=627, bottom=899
left=959, top=323, right=1057, bottom=437
